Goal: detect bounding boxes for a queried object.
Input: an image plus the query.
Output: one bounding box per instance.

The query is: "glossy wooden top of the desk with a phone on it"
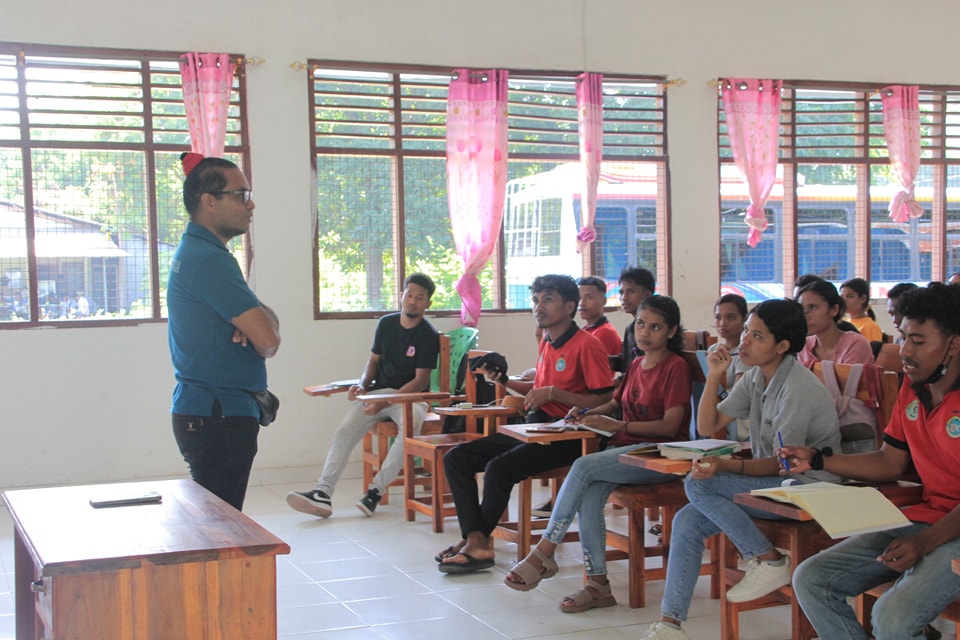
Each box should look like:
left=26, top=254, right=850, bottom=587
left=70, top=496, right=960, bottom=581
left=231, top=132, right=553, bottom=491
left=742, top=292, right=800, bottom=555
left=3, top=480, right=290, bottom=576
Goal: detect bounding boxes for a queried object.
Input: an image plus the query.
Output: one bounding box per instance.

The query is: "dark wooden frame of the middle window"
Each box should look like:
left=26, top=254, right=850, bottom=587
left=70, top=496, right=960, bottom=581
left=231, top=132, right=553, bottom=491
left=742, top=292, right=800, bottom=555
left=306, top=59, right=672, bottom=320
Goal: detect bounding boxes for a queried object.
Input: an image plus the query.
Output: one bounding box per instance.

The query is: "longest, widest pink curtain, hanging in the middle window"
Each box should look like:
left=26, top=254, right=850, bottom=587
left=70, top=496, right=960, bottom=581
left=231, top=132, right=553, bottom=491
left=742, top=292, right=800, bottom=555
left=447, top=69, right=508, bottom=327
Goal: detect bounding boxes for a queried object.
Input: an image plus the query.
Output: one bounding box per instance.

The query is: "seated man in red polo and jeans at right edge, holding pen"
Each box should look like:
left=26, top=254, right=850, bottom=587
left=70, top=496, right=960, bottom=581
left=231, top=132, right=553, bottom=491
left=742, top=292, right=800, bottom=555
left=780, top=283, right=960, bottom=640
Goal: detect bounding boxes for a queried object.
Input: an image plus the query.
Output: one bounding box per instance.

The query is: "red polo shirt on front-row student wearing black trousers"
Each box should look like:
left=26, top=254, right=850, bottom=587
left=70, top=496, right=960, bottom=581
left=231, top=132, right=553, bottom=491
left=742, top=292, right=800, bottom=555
left=533, top=323, right=613, bottom=418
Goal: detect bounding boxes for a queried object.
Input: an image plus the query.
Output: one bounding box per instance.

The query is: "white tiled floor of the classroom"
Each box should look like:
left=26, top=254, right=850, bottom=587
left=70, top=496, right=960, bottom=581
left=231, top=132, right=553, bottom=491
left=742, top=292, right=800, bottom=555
left=0, top=480, right=952, bottom=640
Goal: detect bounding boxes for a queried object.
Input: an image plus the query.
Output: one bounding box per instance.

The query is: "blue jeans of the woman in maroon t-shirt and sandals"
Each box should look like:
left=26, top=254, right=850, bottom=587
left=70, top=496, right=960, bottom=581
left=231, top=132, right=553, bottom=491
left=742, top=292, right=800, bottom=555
left=543, top=445, right=679, bottom=576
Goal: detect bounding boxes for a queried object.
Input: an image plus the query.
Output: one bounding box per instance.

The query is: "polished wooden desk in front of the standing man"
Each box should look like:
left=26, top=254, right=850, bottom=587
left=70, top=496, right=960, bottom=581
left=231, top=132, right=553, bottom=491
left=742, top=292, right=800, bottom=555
left=3, top=480, right=290, bottom=640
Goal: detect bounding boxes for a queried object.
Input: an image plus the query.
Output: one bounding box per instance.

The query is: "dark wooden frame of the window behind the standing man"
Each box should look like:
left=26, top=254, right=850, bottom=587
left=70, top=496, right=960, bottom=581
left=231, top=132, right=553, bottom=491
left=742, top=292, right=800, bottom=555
left=0, top=42, right=252, bottom=330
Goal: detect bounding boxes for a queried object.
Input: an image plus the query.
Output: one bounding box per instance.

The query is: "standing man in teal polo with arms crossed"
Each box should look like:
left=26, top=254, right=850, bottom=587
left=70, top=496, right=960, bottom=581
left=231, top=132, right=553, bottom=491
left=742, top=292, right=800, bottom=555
left=167, top=153, right=280, bottom=509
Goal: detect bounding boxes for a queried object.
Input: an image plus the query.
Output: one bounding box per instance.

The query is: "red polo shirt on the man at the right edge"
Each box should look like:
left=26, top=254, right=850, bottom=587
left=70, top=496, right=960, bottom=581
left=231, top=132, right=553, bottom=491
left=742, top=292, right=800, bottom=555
left=883, top=384, right=960, bottom=524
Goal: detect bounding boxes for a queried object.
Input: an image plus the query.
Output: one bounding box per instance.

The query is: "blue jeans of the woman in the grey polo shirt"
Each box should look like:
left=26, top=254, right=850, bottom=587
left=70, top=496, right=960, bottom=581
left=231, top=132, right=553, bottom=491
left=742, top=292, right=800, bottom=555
left=660, top=471, right=783, bottom=620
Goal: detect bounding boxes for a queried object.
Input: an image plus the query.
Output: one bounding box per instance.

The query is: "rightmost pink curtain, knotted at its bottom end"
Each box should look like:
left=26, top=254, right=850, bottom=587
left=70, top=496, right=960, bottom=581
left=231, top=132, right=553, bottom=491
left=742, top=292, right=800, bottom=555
left=880, top=86, right=923, bottom=222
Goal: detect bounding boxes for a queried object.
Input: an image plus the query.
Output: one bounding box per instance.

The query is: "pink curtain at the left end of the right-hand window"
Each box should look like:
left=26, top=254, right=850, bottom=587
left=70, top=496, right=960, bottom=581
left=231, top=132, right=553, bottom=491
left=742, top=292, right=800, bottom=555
left=723, top=78, right=781, bottom=247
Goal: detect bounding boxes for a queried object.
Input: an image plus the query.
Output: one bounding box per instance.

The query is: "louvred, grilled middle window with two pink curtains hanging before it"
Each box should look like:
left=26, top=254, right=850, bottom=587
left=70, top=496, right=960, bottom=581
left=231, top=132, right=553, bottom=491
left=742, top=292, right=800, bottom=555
left=310, top=61, right=669, bottom=317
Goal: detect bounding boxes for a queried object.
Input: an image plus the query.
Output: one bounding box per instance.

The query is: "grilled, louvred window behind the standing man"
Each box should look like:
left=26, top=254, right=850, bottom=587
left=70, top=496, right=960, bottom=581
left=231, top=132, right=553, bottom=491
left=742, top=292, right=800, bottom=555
left=0, top=43, right=248, bottom=328
